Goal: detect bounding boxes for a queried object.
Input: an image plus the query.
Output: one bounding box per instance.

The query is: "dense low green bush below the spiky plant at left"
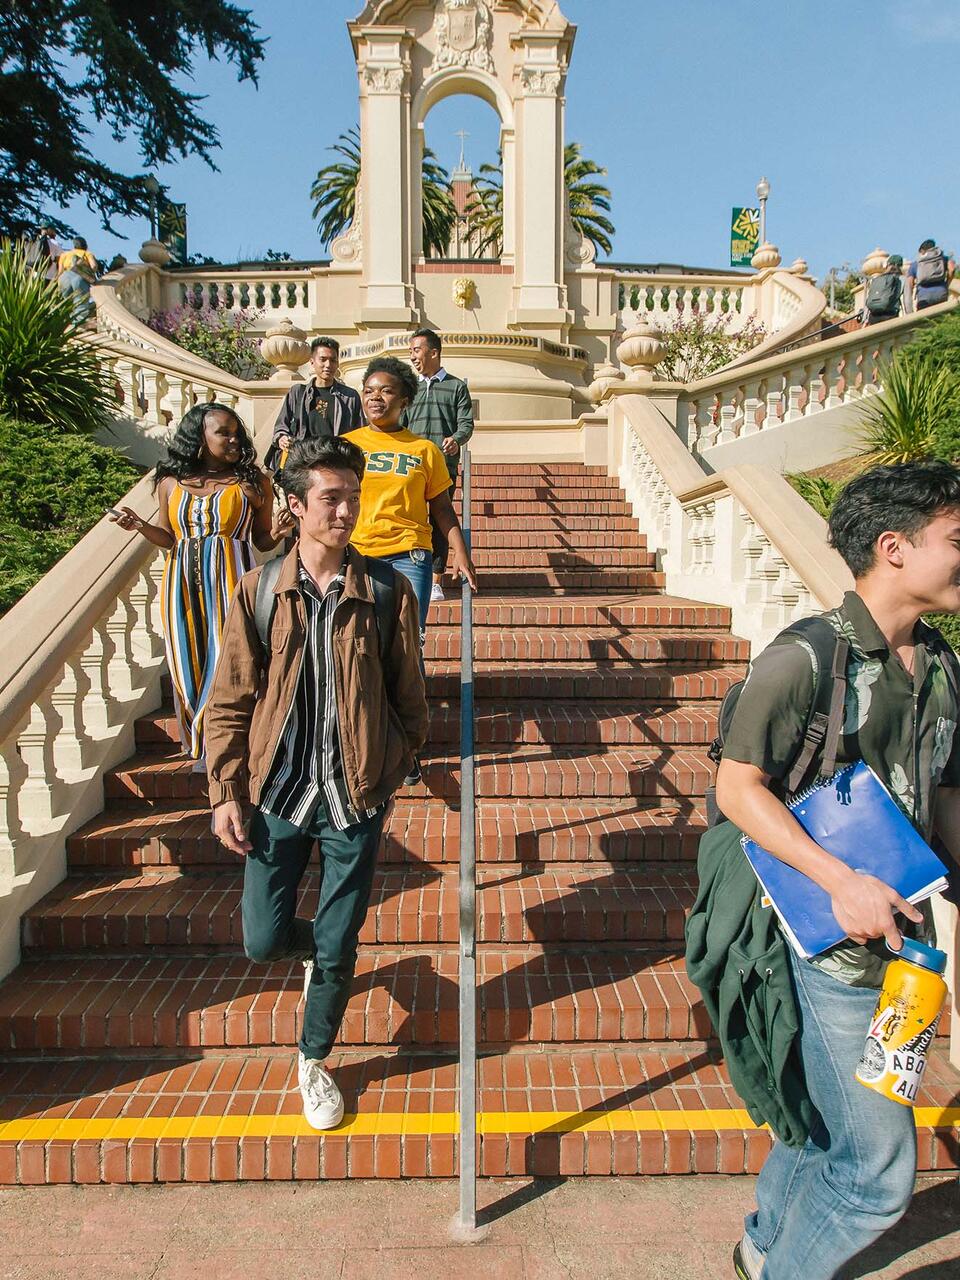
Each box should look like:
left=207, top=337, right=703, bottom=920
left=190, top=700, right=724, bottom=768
left=0, top=417, right=140, bottom=613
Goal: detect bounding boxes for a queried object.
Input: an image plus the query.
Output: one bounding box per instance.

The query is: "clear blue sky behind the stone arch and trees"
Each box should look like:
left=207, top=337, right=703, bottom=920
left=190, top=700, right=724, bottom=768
left=60, top=0, right=960, bottom=275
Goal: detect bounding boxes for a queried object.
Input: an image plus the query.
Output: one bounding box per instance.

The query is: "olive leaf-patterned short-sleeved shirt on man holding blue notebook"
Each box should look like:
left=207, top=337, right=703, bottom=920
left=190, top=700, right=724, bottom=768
left=723, top=591, right=960, bottom=987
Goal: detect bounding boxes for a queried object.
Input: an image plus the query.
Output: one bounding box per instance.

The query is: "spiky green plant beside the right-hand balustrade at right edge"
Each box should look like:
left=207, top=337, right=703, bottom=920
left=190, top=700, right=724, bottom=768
left=860, top=358, right=960, bottom=466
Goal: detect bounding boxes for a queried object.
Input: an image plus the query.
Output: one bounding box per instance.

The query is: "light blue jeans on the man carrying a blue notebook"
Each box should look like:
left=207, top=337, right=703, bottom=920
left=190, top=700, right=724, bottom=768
left=745, top=947, right=916, bottom=1280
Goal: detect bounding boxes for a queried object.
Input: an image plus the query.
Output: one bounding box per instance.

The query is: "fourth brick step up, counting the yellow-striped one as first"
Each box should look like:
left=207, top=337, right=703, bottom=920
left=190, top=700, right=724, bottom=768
left=67, top=799, right=704, bottom=868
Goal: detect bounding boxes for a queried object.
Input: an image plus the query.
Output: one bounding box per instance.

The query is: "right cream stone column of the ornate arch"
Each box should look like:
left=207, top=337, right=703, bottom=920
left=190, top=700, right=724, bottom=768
left=509, top=27, right=573, bottom=337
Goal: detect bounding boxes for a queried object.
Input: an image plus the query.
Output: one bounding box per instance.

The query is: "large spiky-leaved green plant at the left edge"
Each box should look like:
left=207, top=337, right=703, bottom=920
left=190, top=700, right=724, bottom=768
left=0, top=241, right=111, bottom=433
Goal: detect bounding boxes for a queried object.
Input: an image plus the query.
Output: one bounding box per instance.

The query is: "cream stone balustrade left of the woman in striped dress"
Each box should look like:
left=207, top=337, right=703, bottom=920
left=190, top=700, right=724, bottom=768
left=0, top=491, right=163, bottom=975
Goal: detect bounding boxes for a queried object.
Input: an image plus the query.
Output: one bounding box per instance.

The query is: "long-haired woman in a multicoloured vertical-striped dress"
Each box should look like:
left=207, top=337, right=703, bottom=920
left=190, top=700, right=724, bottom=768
left=111, top=404, right=293, bottom=771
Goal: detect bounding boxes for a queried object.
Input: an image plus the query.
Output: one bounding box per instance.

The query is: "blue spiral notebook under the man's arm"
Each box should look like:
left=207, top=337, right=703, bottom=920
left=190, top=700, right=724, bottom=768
left=740, top=760, right=946, bottom=957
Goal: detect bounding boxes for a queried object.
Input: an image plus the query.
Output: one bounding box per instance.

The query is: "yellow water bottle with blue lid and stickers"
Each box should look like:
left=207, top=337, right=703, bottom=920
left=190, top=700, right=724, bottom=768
left=856, top=938, right=947, bottom=1107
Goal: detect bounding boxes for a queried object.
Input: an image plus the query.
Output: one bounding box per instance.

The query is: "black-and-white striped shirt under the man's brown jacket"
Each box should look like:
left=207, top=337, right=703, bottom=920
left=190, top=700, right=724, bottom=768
left=260, top=564, right=376, bottom=831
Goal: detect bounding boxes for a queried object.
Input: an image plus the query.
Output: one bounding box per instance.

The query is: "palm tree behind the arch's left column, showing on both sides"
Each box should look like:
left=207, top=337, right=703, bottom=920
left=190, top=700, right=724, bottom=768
left=310, top=125, right=457, bottom=257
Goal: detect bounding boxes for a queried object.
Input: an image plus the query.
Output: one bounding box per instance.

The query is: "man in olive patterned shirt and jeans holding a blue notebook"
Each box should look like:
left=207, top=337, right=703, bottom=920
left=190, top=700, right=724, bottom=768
left=687, top=462, right=960, bottom=1280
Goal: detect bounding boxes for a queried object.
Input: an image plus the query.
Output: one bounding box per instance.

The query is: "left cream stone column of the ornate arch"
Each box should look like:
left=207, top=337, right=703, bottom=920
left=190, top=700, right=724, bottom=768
left=355, top=27, right=416, bottom=329
